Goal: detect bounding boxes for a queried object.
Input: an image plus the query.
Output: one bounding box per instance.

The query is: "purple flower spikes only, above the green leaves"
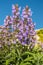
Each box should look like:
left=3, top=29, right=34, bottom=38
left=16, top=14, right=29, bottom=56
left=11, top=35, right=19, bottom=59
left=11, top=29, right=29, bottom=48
left=2, top=4, right=36, bottom=45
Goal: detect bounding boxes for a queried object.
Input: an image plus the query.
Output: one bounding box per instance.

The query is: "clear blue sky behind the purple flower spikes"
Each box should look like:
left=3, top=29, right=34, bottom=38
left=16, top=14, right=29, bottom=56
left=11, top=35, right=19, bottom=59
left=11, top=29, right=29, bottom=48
left=0, top=0, right=43, bottom=29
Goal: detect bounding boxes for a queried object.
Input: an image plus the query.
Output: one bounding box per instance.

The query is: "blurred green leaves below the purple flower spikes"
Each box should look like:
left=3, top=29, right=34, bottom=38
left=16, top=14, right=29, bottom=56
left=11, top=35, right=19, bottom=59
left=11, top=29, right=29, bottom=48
left=0, top=43, right=43, bottom=65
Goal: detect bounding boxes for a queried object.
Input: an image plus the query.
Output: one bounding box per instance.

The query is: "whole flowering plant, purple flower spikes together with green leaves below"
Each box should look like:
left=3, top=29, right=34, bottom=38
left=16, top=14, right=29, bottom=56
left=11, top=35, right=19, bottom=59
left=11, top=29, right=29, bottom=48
left=0, top=5, right=43, bottom=65
